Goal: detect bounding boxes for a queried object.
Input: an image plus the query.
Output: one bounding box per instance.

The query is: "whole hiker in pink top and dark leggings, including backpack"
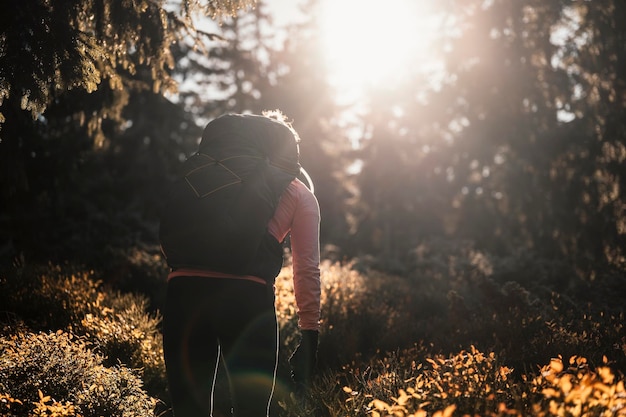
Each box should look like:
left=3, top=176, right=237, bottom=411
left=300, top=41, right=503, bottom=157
left=159, top=111, right=320, bottom=417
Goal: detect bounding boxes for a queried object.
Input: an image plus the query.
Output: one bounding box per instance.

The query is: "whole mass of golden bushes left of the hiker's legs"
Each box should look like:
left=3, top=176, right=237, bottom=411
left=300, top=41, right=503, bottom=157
left=0, top=265, right=165, bottom=417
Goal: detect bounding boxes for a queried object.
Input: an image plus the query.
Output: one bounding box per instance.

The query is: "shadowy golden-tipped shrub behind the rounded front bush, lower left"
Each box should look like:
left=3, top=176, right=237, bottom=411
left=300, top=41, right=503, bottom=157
left=0, top=265, right=166, bottom=396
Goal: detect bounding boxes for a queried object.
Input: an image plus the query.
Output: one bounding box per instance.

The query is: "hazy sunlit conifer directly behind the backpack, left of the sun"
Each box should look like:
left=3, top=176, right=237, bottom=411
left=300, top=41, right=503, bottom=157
left=259, top=0, right=349, bottom=250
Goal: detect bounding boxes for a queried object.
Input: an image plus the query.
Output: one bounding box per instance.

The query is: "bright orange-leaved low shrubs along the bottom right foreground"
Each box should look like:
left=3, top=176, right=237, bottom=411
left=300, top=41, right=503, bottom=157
left=279, top=346, right=626, bottom=417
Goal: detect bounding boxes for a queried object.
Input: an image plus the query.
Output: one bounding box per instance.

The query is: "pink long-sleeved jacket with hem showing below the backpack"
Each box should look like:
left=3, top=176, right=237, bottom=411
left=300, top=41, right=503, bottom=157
left=168, top=179, right=321, bottom=330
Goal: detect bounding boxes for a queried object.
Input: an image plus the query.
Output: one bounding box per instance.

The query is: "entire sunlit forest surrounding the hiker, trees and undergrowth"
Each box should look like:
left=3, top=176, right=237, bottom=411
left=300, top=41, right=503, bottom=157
left=0, top=0, right=626, bottom=417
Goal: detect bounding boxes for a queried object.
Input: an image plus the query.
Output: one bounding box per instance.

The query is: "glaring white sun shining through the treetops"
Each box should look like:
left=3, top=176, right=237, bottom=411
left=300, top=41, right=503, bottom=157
left=320, top=0, right=436, bottom=95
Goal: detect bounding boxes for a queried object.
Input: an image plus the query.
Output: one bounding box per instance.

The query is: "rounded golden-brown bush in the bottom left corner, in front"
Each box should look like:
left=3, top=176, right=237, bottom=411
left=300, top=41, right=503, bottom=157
left=0, top=331, right=156, bottom=417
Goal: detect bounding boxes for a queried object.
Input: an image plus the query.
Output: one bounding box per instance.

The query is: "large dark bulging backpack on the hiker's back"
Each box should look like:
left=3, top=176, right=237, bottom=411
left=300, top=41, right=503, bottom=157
left=159, top=114, right=300, bottom=283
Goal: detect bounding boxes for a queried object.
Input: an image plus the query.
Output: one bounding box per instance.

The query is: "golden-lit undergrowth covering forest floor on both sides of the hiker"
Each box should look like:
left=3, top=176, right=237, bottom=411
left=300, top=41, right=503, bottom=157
left=0, top=242, right=626, bottom=417
